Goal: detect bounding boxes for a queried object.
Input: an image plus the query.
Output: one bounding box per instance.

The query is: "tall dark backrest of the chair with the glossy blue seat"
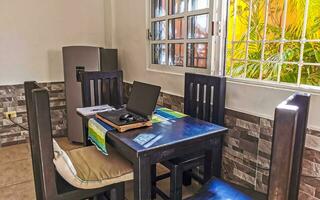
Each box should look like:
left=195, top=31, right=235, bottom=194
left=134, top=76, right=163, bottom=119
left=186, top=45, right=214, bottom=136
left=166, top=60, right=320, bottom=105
left=268, top=93, right=310, bottom=200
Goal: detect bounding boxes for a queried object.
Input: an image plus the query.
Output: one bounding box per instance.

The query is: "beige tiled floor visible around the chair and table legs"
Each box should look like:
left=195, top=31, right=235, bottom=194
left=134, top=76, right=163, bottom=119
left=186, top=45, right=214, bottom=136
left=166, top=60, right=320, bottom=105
left=0, top=138, right=200, bottom=200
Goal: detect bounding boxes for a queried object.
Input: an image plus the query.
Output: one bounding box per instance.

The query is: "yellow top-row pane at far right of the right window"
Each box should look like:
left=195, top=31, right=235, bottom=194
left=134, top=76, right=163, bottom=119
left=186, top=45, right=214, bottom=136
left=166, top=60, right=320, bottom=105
left=306, top=0, right=320, bottom=39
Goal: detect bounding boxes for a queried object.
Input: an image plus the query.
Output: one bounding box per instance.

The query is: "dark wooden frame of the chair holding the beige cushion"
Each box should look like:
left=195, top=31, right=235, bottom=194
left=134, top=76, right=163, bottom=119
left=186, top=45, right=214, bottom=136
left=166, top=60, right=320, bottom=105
left=24, top=82, right=131, bottom=200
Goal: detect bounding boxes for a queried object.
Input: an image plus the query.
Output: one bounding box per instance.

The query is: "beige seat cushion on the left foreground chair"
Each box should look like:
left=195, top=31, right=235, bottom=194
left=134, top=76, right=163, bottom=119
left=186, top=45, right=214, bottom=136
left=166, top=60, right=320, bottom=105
left=53, top=141, right=133, bottom=189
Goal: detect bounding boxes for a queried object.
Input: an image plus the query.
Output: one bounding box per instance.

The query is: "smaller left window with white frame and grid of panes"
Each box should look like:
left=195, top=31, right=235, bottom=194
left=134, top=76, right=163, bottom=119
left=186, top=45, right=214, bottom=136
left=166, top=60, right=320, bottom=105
left=148, top=0, right=213, bottom=73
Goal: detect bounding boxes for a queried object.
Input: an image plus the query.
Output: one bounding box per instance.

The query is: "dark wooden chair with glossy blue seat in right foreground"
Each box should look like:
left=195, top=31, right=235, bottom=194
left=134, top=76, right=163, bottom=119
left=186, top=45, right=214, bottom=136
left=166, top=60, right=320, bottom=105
left=190, top=93, right=310, bottom=200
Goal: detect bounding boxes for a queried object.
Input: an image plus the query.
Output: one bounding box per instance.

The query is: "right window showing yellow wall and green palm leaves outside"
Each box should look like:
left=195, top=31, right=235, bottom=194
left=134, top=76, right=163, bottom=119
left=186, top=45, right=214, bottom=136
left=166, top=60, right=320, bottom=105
left=226, top=0, right=320, bottom=86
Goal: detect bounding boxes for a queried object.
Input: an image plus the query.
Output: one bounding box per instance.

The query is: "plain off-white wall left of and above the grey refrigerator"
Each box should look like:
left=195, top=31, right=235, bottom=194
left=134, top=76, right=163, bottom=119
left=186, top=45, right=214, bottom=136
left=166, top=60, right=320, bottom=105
left=0, top=0, right=108, bottom=85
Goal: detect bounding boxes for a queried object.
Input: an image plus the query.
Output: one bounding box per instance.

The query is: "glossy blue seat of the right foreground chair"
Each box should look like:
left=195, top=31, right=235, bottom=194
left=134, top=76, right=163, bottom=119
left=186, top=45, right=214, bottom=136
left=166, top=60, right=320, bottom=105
left=188, top=178, right=266, bottom=200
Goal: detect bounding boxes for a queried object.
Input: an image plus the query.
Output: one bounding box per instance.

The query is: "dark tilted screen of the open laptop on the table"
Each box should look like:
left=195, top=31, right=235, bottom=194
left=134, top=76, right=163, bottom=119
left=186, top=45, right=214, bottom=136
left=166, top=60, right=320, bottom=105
left=127, top=81, right=161, bottom=117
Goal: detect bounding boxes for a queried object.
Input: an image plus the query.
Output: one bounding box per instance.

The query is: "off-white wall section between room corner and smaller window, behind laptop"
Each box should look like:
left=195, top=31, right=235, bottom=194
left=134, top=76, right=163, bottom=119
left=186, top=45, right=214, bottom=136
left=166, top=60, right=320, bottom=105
left=112, top=0, right=184, bottom=95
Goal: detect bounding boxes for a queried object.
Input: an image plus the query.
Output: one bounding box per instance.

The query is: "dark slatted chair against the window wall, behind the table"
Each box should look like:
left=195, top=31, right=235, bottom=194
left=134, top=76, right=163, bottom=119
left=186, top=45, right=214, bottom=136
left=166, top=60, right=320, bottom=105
left=152, top=73, right=226, bottom=199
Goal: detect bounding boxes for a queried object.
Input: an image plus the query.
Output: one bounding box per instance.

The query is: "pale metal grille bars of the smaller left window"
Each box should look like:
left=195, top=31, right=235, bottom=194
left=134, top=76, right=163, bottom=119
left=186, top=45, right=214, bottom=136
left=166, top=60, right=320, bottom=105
left=147, top=0, right=213, bottom=73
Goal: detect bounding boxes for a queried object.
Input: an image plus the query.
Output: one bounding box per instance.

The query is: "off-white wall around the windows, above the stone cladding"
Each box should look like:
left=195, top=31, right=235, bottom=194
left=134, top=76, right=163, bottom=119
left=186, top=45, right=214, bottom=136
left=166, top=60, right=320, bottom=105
left=111, top=0, right=320, bottom=130
